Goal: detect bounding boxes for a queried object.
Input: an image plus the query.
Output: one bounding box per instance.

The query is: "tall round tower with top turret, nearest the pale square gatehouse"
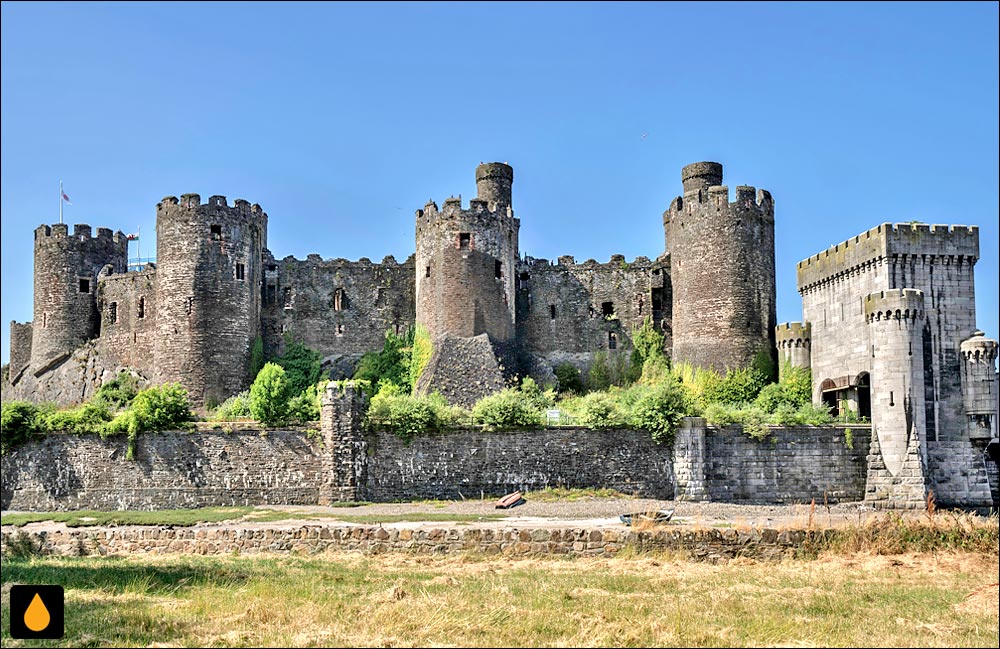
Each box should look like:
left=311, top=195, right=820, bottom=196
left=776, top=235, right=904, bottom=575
left=663, top=162, right=777, bottom=370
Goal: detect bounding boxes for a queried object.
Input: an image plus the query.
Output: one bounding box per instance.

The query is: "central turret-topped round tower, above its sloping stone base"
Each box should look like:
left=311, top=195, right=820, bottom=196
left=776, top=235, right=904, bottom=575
left=416, top=162, right=521, bottom=342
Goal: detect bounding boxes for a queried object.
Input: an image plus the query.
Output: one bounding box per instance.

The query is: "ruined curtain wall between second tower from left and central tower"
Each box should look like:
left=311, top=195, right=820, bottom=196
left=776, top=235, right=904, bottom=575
left=262, top=255, right=415, bottom=371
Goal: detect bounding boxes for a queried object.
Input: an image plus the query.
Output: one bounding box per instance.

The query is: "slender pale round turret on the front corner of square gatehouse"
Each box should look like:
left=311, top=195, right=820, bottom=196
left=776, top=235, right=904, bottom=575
left=864, top=288, right=926, bottom=476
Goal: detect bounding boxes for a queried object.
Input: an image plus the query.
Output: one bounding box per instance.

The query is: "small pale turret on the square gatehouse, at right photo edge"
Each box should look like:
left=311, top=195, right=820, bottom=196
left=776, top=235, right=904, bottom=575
left=960, top=331, right=997, bottom=439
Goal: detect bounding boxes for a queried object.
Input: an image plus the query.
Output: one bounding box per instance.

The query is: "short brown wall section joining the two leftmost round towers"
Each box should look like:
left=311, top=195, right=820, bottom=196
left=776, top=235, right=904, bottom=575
left=97, top=267, right=156, bottom=377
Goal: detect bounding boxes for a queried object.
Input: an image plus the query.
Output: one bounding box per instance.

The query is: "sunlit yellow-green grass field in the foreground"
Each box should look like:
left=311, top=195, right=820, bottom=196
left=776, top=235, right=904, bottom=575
left=2, top=553, right=1000, bottom=647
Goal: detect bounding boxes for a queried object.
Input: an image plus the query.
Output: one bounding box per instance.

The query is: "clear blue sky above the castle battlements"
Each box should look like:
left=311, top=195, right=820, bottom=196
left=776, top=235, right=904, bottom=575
left=0, top=3, right=1000, bottom=361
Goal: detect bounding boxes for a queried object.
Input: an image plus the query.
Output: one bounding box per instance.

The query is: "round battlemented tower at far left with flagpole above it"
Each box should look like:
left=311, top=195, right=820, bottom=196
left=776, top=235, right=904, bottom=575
left=31, top=223, right=128, bottom=372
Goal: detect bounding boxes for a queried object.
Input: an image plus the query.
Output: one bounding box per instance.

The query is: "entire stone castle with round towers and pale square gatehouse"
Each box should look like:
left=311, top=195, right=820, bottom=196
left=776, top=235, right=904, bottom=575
left=3, top=162, right=997, bottom=504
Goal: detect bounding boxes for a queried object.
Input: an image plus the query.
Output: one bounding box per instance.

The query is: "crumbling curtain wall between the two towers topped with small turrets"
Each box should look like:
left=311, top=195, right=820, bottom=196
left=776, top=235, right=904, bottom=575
left=517, top=255, right=670, bottom=367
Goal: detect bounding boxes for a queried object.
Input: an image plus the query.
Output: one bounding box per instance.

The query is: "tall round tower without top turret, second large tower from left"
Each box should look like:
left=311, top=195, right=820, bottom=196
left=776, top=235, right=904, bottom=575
left=153, top=194, right=267, bottom=404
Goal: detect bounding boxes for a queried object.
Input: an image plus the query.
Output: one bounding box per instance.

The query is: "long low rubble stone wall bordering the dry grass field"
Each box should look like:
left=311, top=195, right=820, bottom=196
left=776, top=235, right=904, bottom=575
left=2, top=525, right=820, bottom=562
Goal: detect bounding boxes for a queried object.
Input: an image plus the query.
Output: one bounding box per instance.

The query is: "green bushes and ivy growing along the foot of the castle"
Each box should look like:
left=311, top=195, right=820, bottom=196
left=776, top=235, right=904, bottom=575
left=2, top=319, right=857, bottom=456
